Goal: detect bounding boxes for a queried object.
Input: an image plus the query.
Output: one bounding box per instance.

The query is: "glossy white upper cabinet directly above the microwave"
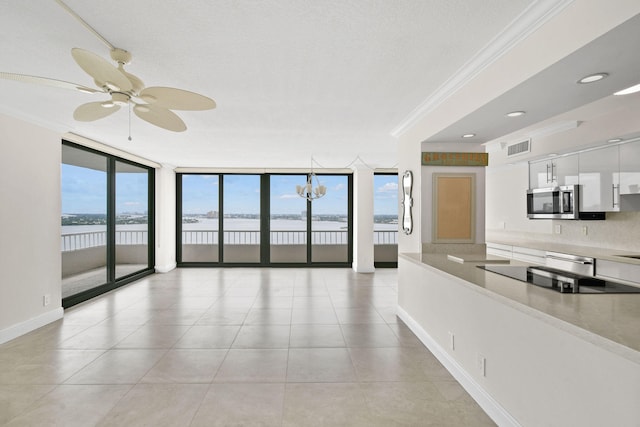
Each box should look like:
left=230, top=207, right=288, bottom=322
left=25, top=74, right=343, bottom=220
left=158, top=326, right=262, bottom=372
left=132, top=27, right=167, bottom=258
left=529, top=154, right=579, bottom=188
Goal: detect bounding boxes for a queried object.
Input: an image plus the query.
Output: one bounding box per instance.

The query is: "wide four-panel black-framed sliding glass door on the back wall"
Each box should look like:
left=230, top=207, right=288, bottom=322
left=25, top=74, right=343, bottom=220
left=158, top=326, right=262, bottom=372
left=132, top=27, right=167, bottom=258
left=176, top=173, right=352, bottom=266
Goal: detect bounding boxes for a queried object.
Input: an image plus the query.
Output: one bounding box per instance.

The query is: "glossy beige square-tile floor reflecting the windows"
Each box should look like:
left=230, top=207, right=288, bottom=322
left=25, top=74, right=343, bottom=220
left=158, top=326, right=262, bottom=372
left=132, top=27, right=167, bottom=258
left=0, top=268, right=494, bottom=427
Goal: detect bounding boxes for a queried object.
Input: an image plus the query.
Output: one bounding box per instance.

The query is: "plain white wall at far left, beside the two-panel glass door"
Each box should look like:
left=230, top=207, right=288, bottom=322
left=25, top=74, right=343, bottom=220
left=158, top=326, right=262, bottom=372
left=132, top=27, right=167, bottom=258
left=0, top=115, right=62, bottom=343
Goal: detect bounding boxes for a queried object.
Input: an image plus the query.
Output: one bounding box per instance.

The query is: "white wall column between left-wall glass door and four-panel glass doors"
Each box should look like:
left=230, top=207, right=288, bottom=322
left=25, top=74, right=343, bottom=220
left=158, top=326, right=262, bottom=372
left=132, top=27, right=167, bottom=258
left=155, top=165, right=176, bottom=273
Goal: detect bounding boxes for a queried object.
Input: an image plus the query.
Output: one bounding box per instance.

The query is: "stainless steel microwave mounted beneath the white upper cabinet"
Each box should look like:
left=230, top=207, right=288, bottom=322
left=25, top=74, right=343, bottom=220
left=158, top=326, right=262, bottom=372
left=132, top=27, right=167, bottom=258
left=527, top=185, right=580, bottom=219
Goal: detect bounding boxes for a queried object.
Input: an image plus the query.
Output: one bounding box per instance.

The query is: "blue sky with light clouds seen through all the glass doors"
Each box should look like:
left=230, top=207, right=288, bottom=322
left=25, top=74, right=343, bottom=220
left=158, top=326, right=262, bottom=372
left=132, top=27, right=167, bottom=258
left=61, top=164, right=398, bottom=215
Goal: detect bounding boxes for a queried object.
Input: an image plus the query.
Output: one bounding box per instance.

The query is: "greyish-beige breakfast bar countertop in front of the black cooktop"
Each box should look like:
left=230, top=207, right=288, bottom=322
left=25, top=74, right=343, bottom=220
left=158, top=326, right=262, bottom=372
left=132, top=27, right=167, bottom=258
left=399, top=254, right=640, bottom=364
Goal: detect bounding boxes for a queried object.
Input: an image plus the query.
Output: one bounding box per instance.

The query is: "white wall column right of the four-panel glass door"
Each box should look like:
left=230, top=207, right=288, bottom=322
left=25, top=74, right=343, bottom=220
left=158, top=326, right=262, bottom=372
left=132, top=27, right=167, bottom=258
left=353, top=166, right=374, bottom=273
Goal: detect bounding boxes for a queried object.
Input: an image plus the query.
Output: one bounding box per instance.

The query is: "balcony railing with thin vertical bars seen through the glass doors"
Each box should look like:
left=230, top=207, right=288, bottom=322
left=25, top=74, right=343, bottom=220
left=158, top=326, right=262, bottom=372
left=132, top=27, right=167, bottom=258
left=61, top=230, right=398, bottom=252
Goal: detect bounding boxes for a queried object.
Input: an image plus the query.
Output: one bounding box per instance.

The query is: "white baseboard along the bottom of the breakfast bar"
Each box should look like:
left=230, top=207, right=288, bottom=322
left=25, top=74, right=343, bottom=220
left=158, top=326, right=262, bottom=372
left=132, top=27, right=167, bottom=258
left=397, top=306, right=521, bottom=427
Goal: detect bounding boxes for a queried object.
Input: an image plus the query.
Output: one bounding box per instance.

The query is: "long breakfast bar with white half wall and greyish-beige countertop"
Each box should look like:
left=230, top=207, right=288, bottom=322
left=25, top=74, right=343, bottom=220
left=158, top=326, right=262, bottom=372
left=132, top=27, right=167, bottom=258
left=398, top=253, right=640, bottom=426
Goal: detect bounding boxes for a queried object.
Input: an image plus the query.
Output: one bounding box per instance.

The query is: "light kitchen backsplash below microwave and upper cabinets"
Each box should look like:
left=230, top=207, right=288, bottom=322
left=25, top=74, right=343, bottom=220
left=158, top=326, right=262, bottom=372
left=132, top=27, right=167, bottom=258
left=486, top=212, right=640, bottom=252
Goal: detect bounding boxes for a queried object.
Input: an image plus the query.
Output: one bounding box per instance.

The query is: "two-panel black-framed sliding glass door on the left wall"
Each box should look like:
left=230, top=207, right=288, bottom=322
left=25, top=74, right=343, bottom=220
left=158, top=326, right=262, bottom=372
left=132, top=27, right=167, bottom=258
left=61, top=141, right=154, bottom=307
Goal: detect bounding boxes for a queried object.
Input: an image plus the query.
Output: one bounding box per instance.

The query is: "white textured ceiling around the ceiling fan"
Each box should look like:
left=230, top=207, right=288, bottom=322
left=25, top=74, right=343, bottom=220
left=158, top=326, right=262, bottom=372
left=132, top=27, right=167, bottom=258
left=0, top=0, right=533, bottom=168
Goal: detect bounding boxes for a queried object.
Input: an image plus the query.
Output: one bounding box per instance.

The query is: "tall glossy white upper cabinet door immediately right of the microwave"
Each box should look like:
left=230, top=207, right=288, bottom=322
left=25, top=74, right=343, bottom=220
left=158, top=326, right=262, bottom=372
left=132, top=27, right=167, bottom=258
left=579, top=146, right=620, bottom=212
